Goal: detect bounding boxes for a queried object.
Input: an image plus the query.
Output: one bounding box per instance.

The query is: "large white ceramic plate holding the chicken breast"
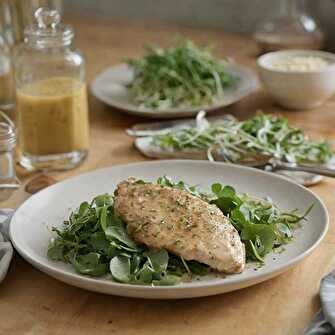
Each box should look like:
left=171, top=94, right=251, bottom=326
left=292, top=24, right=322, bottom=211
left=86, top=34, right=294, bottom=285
left=10, top=160, right=328, bottom=299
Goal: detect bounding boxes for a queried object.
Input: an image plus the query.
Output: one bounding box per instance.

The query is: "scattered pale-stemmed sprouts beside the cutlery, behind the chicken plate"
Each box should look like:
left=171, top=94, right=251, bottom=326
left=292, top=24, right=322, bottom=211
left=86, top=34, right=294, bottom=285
left=152, top=112, right=334, bottom=164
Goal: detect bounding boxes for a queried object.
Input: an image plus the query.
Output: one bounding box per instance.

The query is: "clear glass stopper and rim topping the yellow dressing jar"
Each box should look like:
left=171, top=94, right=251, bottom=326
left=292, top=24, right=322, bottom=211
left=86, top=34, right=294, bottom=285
left=25, top=7, right=74, bottom=47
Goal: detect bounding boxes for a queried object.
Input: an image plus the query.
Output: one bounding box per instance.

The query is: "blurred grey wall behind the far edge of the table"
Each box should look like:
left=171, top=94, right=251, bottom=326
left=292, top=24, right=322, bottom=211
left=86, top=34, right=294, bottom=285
left=63, top=0, right=335, bottom=50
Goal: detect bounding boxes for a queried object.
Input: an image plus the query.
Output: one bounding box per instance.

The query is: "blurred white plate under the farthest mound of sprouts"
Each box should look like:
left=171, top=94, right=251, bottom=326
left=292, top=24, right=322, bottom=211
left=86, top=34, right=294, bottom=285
left=91, top=64, right=259, bottom=118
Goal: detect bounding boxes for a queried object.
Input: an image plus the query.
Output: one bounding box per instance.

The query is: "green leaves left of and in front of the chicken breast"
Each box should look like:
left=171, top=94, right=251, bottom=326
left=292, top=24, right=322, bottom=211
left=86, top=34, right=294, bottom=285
left=48, top=190, right=209, bottom=285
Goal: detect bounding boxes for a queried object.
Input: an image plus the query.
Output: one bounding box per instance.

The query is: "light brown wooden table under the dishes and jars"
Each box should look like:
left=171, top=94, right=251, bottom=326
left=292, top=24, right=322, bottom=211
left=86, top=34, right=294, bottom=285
left=0, top=19, right=335, bottom=335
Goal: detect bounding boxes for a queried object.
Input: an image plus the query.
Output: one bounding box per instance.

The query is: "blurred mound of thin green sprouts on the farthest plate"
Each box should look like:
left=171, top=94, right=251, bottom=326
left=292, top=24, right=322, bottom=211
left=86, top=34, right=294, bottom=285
left=128, top=40, right=232, bottom=109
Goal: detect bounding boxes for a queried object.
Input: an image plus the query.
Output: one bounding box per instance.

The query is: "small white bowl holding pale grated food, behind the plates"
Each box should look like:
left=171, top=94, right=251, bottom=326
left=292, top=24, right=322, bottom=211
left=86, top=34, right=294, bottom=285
left=257, top=50, right=335, bottom=109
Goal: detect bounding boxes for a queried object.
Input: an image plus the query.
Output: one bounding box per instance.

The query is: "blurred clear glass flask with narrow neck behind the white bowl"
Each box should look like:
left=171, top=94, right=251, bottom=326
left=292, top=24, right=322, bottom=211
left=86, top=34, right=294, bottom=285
left=254, top=0, right=324, bottom=53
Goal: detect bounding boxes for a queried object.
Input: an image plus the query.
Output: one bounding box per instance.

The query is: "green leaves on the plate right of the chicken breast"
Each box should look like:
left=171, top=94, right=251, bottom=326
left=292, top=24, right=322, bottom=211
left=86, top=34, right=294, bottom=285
left=211, top=183, right=312, bottom=262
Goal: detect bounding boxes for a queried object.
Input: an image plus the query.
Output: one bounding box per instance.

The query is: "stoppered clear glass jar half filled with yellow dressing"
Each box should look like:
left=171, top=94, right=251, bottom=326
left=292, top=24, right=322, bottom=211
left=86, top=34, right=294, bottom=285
left=15, top=8, right=89, bottom=170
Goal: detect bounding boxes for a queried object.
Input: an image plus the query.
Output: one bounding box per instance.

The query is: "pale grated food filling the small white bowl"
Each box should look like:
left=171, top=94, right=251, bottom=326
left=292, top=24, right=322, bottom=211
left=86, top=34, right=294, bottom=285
left=271, top=56, right=332, bottom=72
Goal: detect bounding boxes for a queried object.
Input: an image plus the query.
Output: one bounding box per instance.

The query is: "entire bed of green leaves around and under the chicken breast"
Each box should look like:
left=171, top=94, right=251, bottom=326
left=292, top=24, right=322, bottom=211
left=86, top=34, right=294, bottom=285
left=48, top=176, right=312, bottom=286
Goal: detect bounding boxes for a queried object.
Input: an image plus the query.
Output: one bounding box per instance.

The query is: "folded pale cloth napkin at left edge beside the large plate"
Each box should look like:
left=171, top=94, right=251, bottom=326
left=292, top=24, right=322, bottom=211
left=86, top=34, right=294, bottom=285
left=0, top=209, right=14, bottom=283
